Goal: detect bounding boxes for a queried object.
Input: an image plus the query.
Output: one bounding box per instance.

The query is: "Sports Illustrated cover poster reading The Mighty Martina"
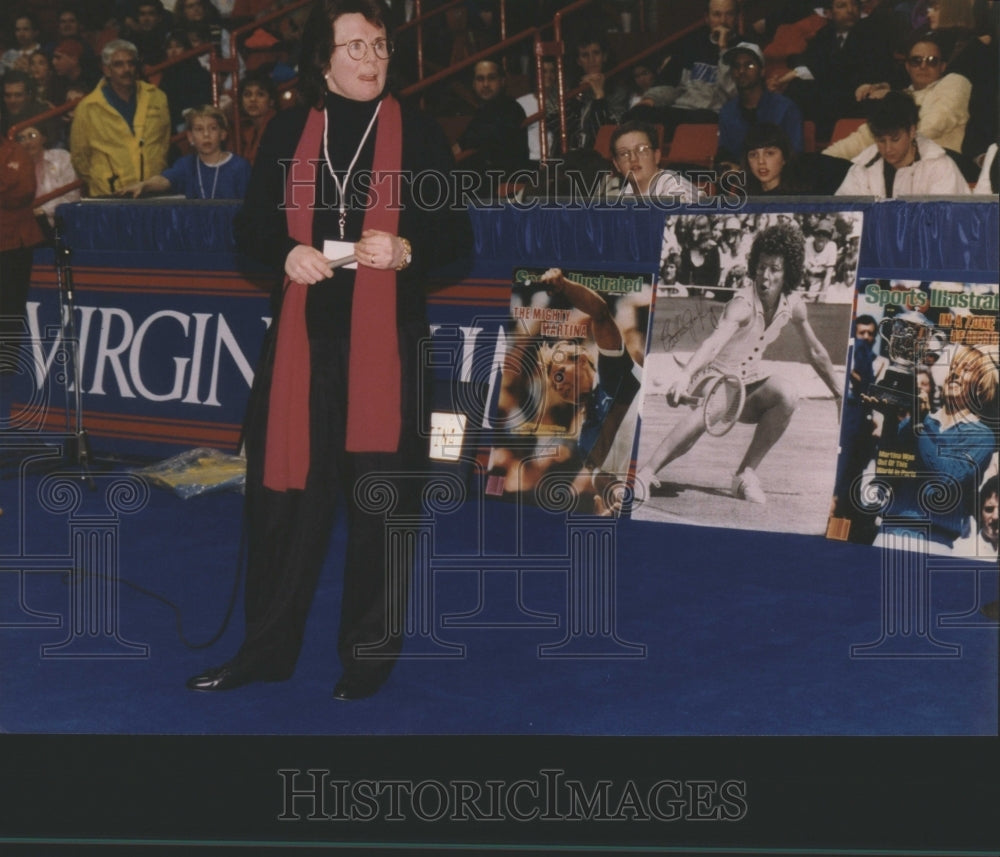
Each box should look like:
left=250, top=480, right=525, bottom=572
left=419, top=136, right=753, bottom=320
left=479, top=267, right=653, bottom=515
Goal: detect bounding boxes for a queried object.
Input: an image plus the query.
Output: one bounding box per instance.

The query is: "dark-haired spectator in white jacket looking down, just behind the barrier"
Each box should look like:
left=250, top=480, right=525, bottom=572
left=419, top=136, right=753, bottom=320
left=837, top=91, right=969, bottom=198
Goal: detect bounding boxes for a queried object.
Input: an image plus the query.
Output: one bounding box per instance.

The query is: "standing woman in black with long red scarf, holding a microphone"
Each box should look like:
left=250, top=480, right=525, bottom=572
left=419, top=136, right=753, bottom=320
left=188, top=0, right=471, bottom=699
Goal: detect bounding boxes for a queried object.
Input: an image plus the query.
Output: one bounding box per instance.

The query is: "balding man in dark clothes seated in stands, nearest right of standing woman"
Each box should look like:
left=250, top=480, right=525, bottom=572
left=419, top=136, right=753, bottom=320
left=452, top=60, right=528, bottom=181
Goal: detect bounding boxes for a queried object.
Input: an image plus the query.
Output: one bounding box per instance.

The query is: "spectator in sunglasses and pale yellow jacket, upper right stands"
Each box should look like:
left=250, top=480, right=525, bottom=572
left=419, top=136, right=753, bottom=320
left=823, top=33, right=972, bottom=160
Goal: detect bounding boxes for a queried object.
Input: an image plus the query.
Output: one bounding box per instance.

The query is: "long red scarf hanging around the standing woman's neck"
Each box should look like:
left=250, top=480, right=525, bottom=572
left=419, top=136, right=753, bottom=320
left=264, top=95, right=402, bottom=491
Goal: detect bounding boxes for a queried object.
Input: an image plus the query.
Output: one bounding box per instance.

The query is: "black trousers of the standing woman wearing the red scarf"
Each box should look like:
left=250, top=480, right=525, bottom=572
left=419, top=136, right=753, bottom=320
left=239, top=323, right=427, bottom=681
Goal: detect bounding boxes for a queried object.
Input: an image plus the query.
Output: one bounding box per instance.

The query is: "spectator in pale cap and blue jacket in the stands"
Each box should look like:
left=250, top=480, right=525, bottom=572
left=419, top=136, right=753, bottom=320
left=716, top=42, right=803, bottom=169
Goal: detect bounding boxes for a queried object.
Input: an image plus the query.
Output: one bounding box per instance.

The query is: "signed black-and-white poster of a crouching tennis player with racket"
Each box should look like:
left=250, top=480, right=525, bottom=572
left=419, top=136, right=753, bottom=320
left=632, top=212, right=862, bottom=535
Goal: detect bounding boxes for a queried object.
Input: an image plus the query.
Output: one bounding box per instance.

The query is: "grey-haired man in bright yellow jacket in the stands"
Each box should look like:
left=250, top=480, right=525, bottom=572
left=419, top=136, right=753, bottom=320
left=70, top=39, right=170, bottom=196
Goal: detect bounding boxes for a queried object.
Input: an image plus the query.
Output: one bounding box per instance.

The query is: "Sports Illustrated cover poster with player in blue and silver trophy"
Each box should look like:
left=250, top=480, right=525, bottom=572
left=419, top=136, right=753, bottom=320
left=827, top=280, right=1000, bottom=562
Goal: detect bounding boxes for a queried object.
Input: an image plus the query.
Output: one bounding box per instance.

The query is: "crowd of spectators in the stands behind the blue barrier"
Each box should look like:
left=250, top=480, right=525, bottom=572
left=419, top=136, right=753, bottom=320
left=0, top=0, right=1000, bottom=241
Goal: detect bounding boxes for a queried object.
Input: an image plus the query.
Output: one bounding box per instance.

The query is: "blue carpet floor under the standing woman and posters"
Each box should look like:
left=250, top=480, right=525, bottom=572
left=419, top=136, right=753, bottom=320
left=0, top=442, right=997, bottom=736
